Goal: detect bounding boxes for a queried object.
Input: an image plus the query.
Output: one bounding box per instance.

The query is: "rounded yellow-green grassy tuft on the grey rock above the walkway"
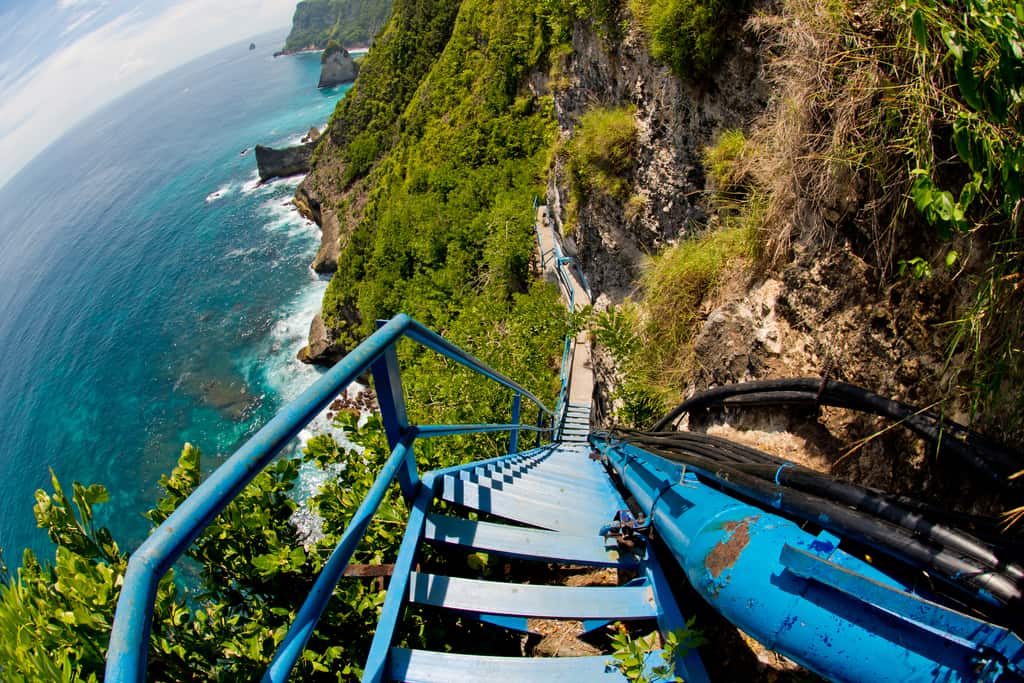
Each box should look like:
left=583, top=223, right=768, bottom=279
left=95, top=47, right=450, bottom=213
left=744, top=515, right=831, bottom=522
left=568, top=106, right=637, bottom=200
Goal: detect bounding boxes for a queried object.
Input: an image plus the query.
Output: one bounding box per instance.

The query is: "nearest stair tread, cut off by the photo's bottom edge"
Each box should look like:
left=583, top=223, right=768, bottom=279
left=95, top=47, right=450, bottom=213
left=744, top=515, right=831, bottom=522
left=388, top=647, right=634, bottom=683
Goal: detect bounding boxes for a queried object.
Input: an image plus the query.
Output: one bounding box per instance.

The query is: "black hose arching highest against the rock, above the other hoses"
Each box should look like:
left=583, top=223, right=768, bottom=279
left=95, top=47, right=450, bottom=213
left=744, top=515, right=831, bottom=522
left=650, top=378, right=1024, bottom=487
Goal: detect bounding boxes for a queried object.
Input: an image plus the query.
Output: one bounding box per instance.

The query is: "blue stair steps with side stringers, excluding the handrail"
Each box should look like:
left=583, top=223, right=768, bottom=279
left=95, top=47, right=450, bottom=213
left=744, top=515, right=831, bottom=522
left=364, top=442, right=708, bottom=682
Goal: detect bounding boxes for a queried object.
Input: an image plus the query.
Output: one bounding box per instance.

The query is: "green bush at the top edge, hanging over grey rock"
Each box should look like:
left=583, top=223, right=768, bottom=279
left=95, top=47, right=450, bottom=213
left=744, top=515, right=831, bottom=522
left=631, top=0, right=742, bottom=81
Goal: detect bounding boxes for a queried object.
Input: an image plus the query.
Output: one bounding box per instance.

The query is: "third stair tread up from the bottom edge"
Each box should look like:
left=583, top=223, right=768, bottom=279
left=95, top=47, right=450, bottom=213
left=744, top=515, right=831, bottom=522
left=424, top=514, right=636, bottom=566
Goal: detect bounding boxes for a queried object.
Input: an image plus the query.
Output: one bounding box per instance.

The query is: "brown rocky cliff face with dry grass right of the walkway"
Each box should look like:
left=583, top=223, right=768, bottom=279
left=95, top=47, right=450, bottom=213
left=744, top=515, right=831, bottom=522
left=547, top=3, right=1020, bottom=514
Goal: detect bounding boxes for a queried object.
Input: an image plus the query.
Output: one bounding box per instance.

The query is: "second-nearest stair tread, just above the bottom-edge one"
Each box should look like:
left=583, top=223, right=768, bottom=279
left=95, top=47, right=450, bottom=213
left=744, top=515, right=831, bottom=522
left=409, top=571, right=658, bottom=620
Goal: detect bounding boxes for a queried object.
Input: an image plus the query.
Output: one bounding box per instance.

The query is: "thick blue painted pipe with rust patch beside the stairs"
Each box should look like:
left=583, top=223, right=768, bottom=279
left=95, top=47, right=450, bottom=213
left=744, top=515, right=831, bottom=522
left=592, top=436, right=1024, bottom=682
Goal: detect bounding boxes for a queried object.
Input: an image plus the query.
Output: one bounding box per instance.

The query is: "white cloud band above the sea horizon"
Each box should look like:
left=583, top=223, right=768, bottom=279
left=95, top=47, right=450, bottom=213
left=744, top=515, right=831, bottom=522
left=0, top=0, right=295, bottom=186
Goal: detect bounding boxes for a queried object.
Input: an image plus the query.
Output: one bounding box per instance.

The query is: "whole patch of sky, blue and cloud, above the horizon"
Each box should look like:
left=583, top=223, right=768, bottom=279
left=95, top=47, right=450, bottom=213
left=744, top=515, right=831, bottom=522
left=0, top=0, right=297, bottom=187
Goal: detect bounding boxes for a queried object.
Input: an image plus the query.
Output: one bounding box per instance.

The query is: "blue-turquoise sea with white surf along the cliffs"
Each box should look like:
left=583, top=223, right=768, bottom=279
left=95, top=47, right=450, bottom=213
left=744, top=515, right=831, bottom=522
left=0, top=32, right=347, bottom=565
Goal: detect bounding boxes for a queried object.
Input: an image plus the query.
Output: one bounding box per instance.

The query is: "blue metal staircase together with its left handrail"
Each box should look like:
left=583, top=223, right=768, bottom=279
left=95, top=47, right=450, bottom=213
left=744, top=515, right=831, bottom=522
left=106, top=315, right=708, bottom=683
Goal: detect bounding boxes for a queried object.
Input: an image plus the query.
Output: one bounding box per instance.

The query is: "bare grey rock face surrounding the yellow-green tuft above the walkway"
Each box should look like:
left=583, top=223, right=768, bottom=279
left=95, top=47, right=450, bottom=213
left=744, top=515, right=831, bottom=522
left=544, top=23, right=770, bottom=303
